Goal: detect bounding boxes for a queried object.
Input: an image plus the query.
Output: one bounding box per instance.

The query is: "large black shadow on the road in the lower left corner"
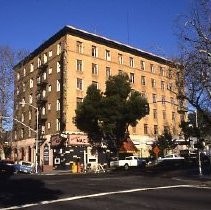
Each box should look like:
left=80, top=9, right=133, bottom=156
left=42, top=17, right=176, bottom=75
left=0, top=175, right=62, bottom=209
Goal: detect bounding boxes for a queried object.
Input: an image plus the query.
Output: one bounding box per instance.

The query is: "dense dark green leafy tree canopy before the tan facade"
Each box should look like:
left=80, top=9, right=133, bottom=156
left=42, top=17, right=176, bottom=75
left=75, top=74, right=149, bottom=152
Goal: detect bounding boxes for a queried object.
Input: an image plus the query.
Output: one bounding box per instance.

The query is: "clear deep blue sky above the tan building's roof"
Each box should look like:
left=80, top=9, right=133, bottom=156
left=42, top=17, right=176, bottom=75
left=0, top=0, right=191, bottom=57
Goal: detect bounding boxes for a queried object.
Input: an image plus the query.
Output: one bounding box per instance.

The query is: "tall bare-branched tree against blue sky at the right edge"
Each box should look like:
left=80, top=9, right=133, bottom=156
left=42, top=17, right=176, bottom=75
left=177, top=0, right=211, bottom=126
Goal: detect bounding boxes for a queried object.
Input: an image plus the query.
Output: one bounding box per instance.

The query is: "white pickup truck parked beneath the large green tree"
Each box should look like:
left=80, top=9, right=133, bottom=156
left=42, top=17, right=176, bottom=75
left=110, top=156, right=146, bottom=170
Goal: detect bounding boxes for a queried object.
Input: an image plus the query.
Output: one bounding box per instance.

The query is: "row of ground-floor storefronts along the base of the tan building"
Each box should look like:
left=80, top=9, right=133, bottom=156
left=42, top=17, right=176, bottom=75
left=11, top=133, right=155, bottom=172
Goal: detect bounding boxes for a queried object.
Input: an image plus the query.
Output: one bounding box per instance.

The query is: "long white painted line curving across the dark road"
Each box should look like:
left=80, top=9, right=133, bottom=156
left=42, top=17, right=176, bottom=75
left=0, top=185, right=211, bottom=210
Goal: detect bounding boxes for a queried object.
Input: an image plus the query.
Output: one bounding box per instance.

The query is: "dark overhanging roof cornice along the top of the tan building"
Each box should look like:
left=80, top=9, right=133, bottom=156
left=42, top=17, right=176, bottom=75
left=14, top=25, right=175, bottom=69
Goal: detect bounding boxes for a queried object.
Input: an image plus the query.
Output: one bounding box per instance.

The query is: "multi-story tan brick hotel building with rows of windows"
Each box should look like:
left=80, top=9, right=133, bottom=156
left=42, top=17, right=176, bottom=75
left=13, top=26, right=184, bottom=171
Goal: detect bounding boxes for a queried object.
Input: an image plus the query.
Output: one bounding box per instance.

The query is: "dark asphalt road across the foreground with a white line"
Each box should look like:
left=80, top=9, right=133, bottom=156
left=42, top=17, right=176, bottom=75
left=0, top=172, right=211, bottom=210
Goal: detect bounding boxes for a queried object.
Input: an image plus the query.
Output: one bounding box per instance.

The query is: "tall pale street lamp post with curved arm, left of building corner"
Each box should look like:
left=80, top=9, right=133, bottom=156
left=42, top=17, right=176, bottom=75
left=20, top=102, right=39, bottom=173
